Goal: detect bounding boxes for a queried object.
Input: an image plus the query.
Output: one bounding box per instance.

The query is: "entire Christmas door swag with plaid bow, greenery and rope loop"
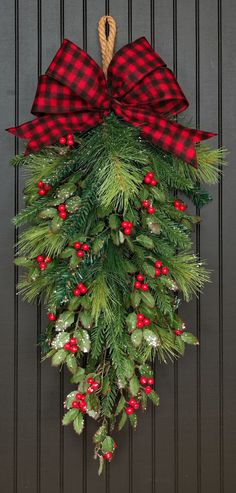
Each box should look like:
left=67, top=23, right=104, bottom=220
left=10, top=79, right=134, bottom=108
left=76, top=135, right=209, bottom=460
left=8, top=17, right=223, bottom=472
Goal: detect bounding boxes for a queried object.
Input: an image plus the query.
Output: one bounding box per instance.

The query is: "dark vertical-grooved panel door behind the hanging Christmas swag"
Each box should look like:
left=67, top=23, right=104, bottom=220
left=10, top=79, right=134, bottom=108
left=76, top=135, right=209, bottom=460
left=0, top=0, right=236, bottom=493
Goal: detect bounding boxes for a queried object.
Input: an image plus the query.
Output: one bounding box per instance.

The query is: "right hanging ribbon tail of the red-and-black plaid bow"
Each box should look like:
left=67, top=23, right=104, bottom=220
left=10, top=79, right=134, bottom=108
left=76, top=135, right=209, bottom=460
left=114, top=105, right=216, bottom=168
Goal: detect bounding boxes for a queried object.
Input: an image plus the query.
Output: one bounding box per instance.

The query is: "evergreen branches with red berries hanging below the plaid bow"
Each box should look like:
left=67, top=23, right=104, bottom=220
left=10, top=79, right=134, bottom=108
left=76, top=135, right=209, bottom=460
left=13, top=114, right=224, bottom=472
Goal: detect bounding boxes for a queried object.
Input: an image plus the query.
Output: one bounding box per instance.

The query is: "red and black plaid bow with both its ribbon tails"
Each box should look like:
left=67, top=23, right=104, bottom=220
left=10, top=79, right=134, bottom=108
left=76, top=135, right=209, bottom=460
left=8, top=37, right=215, bottom=166
